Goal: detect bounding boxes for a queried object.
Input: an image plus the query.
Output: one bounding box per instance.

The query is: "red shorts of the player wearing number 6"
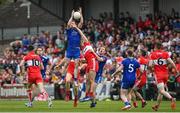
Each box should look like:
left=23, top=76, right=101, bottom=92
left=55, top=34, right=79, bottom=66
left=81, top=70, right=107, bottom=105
left=155, top=74, right=168, bottom=84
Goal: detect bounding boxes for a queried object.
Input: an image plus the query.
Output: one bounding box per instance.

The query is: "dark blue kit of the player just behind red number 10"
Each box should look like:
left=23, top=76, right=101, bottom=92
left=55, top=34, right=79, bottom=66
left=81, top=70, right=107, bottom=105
left=40, top=56, right=49, bottom=78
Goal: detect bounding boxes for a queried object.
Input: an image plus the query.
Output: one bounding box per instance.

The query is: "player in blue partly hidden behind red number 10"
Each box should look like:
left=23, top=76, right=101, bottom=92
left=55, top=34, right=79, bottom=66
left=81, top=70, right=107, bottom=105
left=36, top=47, right=52, bottom=80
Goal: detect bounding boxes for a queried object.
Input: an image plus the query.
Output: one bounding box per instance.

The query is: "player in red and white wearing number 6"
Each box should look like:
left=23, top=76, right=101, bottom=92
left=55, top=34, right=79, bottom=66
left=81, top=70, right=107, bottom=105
left=149, top=43, right=178, bottom=111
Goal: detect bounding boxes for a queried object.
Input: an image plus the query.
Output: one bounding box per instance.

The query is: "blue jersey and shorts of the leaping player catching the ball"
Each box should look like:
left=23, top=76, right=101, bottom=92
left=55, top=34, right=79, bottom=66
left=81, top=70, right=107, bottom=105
left=66, top=28, right=81, bottom=59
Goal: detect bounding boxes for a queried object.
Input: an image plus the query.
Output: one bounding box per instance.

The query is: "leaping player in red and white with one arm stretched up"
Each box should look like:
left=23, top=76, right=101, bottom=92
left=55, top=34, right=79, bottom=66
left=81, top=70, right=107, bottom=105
left=74, top=23, right=103, bottom=108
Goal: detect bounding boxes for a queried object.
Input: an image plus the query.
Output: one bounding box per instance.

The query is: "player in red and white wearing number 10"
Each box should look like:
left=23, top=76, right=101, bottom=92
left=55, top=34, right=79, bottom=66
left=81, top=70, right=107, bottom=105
left=20, top=46, right=52, bottom=107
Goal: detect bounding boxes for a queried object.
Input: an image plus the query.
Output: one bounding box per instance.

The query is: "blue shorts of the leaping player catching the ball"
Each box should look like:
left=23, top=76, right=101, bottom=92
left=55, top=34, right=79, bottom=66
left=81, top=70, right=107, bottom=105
left=66, top=49, right=80, bottom=59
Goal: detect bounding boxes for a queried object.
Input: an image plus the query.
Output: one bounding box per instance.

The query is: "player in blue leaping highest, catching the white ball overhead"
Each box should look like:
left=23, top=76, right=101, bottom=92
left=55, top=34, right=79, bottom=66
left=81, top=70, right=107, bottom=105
left=55, top=8, right=83, bottom=103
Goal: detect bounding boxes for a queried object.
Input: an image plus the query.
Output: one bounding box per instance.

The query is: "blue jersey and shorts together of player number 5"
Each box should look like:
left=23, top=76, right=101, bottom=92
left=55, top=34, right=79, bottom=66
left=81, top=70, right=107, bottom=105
left=121, top=58, right=140, bottom=89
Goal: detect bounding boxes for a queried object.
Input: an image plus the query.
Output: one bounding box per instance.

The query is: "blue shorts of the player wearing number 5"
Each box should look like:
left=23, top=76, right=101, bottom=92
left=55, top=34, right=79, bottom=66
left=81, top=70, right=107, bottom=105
left=120, top=81, right=135, bottom=89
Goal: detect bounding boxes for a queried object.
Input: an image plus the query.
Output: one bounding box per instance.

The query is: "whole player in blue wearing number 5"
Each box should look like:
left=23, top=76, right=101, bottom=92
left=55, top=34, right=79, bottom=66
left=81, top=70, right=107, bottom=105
left=113, top=49, right=141, bottom=110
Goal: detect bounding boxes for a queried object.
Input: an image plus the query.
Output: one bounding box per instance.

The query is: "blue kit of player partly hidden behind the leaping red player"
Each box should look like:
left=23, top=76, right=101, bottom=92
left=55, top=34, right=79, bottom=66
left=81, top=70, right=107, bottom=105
left=95, top=56, right=107, bottom=83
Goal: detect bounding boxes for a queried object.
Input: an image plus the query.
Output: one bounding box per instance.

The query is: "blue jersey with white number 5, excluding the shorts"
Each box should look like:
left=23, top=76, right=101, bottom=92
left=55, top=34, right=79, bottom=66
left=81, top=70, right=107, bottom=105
left=122, top=58, right=140, bottom=82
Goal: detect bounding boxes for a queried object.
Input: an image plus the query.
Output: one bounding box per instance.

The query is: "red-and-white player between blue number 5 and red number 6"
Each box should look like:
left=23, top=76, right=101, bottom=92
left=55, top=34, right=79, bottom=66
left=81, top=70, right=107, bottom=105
left=133, top=49, right=149, bottom=108
